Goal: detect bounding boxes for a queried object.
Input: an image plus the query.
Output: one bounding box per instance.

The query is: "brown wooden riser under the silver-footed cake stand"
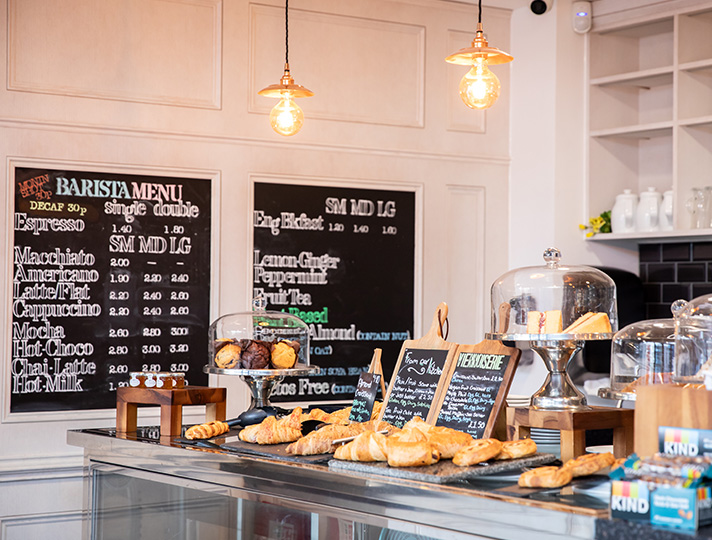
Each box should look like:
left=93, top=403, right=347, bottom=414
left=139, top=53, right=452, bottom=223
left=507, top=407, right=634, bottom=463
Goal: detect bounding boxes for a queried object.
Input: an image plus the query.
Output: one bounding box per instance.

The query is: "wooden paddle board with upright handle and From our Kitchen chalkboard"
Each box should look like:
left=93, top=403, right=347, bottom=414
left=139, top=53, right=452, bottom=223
left=380, top=303, right=457, bottom=427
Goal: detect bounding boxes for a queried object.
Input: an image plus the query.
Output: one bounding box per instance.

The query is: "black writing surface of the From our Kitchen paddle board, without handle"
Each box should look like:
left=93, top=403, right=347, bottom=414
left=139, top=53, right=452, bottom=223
left=381, top=349, right=449, bottom=427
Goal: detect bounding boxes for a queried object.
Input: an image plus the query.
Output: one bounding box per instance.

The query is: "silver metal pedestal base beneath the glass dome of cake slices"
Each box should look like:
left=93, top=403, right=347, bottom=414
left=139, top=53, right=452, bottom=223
left=485, top=333, right=613, bottom=410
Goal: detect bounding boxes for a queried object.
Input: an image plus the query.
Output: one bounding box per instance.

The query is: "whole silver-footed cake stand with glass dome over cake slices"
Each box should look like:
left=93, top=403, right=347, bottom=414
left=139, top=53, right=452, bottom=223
left=487, top=248, right=618, bottom=409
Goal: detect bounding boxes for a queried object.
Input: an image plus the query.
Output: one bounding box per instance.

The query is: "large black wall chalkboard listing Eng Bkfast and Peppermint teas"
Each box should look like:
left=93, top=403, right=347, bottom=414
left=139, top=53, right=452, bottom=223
left=252, top=182, right=415, bottom=403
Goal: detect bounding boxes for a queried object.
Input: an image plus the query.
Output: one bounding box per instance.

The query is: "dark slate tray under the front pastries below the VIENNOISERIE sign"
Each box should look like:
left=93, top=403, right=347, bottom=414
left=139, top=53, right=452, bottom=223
left=329, top=453, right=558, bottom=484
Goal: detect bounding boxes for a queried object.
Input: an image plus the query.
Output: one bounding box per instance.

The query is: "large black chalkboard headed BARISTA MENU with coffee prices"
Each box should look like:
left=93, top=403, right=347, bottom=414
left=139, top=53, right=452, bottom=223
left=10, top=168, right=211, bottom=412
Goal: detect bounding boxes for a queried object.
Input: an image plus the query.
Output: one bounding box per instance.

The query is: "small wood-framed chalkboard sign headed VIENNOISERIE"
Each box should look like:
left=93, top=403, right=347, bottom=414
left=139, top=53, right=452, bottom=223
left=435, top=340, right=521, bottom=439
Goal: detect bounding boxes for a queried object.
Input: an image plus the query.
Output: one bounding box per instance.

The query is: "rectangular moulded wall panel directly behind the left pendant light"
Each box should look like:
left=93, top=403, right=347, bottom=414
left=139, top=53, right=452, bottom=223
left=250, top=4, right=425, bottom=127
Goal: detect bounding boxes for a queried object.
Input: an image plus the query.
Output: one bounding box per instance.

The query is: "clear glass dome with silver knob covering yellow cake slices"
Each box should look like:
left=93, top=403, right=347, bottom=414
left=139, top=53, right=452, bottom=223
left=491, top=248, right=618, bottom=339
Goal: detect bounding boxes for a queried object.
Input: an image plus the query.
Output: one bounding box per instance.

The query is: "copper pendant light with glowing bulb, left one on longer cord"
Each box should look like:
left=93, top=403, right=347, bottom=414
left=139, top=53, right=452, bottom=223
left=257, top=0, right=314, bottom=137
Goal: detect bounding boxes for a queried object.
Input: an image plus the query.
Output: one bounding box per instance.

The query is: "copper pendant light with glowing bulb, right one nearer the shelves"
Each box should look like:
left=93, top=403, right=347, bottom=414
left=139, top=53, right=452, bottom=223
left=445, top=0, right=514, bottom=109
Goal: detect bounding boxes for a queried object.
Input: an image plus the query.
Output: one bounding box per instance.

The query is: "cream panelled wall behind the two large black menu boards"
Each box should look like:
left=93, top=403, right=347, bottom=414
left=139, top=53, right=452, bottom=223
left=0, top=0, right=511, bottom=539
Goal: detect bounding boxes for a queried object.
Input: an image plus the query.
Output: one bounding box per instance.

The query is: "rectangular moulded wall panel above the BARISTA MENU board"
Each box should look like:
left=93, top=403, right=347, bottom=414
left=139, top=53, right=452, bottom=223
left=8, top=0, right=222, bottom=109
